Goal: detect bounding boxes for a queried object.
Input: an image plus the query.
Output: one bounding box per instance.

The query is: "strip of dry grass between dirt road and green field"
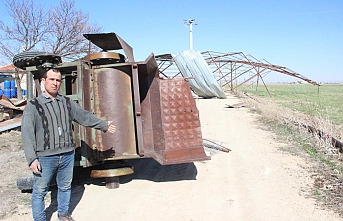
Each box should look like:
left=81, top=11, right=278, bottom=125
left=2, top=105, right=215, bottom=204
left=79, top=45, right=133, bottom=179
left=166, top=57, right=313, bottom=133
left=239, top=90, right=343, bottom=217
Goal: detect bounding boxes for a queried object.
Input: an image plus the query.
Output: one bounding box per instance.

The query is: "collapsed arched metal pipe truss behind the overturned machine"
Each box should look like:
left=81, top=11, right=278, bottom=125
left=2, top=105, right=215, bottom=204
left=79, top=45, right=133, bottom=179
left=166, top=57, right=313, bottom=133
left=156, top=51, right=320, bottom=96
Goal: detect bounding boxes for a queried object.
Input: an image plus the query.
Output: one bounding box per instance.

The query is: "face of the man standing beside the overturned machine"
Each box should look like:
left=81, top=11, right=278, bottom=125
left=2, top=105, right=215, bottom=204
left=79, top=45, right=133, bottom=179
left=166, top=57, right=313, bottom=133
left=42, top=70, right=62, bottom=97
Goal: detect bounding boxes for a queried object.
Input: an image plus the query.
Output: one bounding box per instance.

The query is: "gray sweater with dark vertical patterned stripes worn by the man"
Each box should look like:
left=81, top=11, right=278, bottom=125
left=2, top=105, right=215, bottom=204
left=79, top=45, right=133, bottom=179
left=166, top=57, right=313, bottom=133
left=21, top=94, right=108, bottom=165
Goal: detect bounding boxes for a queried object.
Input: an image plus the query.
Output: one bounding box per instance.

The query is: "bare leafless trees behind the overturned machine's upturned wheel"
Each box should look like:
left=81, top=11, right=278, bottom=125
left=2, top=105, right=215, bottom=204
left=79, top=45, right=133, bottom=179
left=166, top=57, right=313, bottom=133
left=0, top=0, right=101, bottom=63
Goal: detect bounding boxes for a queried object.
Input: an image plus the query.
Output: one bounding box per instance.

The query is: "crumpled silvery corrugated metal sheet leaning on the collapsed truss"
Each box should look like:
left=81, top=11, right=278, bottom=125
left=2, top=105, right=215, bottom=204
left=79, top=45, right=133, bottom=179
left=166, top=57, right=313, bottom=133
left=172, top=50, right=226, bottom=98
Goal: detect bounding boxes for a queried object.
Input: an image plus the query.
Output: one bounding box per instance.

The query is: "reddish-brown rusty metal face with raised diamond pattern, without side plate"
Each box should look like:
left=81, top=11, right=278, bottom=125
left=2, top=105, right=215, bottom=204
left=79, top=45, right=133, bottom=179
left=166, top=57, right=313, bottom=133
left=154, top=78, right=209, bottom=164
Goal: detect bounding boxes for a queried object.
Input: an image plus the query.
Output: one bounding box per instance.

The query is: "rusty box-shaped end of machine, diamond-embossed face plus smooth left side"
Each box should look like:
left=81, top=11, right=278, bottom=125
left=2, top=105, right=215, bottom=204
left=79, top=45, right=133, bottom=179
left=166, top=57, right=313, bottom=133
left=144, top=79, right=209, bottom=164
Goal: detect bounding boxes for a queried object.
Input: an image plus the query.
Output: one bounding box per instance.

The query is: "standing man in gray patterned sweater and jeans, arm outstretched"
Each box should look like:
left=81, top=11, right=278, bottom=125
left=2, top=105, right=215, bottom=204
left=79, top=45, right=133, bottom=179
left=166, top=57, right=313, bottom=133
left=21, top=69, right=116, bottom=221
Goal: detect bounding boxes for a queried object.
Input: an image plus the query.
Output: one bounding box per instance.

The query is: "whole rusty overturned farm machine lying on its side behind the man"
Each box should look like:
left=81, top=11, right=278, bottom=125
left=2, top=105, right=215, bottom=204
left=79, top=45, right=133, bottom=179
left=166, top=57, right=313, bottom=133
left=13, top=33, right=210, bottom=188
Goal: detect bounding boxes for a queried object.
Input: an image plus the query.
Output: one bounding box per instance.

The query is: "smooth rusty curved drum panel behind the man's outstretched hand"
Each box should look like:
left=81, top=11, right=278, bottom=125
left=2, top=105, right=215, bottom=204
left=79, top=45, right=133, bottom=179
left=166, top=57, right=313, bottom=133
left=92, top=68, right=137, bottom=160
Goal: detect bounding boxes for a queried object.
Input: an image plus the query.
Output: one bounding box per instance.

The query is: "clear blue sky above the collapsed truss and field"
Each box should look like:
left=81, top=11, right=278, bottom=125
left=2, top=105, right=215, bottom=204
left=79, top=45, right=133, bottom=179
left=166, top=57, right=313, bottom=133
left=0, top=0, right=343, bottom=82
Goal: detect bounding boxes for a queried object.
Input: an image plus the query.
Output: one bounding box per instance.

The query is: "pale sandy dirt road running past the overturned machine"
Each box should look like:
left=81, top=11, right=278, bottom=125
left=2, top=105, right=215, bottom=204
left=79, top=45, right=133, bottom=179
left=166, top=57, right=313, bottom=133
left=5, top=97, right=342, bottom=221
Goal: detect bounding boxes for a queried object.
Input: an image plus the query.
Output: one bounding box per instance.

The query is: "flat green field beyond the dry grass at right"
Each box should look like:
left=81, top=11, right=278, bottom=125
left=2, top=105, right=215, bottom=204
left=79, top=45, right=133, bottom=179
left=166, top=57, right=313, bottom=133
left=238, top=84, right=343, bottom=126
